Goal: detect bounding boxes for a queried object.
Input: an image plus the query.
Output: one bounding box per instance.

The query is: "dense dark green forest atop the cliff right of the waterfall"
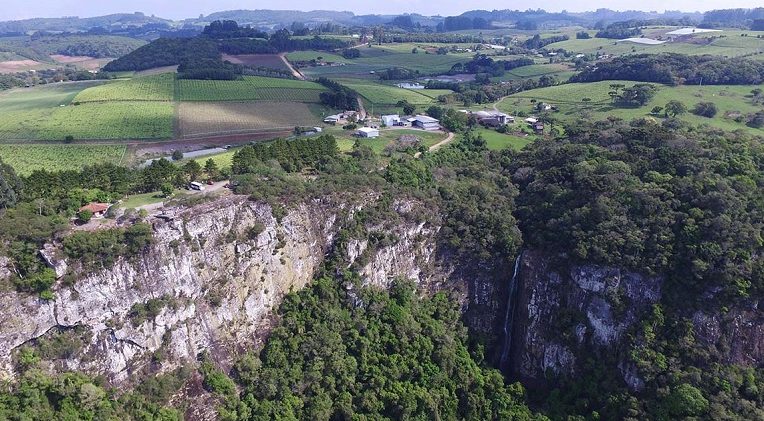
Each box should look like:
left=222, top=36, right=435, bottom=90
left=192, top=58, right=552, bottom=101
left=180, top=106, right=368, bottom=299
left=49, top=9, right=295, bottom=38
left=508, top=120, right=764, bottom=297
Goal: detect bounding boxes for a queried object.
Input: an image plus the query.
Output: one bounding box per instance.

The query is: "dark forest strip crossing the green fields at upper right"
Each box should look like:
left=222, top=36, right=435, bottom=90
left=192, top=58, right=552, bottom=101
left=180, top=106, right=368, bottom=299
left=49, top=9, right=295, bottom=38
left=570, top=53, right=764, bottom=85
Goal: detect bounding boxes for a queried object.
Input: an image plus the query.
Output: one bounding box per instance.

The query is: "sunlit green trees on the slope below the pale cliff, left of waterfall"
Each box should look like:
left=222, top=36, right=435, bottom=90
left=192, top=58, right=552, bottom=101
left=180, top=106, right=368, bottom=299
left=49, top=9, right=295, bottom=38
left=209, top=273, right=544, bottom=420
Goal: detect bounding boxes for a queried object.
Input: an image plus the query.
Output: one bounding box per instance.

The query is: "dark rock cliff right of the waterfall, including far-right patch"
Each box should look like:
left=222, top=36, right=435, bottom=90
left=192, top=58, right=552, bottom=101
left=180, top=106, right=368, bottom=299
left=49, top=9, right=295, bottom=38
left=504, top=250, right=764, bottom=391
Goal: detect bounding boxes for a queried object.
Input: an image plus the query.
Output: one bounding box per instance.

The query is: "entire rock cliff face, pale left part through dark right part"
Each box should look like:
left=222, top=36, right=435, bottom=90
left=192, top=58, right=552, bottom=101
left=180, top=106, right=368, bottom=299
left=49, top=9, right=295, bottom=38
left=0, top=194, right=764, bottom=390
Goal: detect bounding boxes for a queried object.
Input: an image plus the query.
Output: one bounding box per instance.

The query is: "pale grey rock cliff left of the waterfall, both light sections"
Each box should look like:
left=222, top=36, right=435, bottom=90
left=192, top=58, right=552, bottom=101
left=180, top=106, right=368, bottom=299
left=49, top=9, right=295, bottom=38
left=0, top=195, right=510, bottom=384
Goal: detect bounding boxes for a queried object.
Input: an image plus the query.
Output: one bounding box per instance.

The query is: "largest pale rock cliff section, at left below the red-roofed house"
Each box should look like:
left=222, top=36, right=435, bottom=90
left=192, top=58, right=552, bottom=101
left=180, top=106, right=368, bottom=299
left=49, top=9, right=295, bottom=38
left=0, top=197, right=342, bottom=382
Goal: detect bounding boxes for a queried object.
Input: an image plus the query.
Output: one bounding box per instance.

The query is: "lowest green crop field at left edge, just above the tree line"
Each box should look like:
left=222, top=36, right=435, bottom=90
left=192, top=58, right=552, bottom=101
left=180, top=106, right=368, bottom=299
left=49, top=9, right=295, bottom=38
left=0, top=144, right=126, bottom=175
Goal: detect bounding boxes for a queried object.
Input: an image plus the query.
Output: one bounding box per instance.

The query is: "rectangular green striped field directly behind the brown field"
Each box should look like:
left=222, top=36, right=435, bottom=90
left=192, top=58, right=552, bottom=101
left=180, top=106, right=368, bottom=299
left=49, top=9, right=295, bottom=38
left=175, top=76, right=325, bottom=102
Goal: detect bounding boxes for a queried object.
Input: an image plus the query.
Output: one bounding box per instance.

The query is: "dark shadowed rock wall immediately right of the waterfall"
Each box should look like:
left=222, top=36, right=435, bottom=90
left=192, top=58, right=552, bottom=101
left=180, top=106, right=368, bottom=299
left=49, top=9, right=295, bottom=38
left=509, top=250, right=663, bottom=388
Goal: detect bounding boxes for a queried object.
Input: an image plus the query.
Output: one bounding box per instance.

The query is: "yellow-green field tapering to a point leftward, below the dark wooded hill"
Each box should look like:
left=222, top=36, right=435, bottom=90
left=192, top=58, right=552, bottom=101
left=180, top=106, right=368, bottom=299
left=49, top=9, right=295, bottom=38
left=74, top=74, right=175, bottom=102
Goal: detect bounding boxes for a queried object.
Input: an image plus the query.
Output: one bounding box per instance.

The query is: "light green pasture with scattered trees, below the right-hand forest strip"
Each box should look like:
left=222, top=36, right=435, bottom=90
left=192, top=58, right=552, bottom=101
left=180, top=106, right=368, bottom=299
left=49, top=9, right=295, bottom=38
left=499, top=81, right=764, bottom=134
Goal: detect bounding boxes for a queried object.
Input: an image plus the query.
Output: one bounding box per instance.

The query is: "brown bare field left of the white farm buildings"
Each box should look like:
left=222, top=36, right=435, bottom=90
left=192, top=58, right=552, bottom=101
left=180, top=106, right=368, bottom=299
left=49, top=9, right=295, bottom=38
left=177, top=102, right=319, bottom=138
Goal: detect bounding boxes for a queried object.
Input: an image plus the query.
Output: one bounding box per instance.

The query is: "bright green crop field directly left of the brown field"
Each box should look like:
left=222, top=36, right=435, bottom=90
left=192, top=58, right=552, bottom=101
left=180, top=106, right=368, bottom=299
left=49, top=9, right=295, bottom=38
left=0, top=101, right=173, bottom=140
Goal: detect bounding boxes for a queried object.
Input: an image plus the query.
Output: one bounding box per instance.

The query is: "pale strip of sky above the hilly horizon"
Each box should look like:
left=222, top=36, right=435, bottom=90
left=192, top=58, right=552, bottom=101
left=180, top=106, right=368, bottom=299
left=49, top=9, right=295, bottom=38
left=0, top=0, right=761, bottom=20
